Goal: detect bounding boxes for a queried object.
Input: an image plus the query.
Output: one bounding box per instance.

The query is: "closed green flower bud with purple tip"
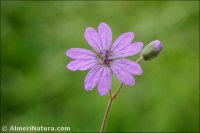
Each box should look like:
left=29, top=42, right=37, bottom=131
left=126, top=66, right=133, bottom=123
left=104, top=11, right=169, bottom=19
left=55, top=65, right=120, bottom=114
left=140, top=40, right=163, bottom=60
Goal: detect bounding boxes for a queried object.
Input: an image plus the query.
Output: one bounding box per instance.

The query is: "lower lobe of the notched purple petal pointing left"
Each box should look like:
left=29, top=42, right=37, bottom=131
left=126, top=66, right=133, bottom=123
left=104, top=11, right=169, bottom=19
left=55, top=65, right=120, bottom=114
left=67, top=60, right=99, bottom=71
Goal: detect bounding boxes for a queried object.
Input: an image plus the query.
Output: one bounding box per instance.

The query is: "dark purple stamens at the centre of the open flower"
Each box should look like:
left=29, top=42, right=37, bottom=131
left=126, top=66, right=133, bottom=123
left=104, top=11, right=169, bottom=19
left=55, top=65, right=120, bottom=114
left=100, top=50, right=112, bottom=66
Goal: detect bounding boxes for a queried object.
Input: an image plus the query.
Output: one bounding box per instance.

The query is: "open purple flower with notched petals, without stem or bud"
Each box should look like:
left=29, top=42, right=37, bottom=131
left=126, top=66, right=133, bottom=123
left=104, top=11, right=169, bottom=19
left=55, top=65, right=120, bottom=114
left=66, top=23, right=143, bottom=96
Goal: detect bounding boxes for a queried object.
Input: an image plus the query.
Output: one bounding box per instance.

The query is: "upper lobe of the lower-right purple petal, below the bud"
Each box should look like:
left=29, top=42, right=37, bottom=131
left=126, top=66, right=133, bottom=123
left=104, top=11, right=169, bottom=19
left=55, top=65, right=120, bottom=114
left=114, top=59, right=142, bottom=75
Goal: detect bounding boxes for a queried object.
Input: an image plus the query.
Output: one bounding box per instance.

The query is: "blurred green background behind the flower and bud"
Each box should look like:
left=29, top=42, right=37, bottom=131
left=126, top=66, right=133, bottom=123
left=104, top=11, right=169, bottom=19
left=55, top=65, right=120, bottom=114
left=1, top=1, right=199, bottom=132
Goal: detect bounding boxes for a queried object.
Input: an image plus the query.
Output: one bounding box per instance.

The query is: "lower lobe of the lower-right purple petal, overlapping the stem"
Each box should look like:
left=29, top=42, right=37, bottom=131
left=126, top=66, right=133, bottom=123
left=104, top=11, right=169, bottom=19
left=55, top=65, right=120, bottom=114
left=111, top=64, right=135, bottom=86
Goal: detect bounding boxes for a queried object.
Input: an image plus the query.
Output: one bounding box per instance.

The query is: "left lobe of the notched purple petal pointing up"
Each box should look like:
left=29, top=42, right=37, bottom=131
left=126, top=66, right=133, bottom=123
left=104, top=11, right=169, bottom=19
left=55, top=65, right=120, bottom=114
left=84, top=27, right=102, bottom=53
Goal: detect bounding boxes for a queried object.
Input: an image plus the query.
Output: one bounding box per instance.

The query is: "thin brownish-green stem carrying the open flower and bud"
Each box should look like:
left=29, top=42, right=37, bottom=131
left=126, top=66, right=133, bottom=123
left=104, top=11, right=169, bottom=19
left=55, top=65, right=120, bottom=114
left=100, top=57, right=143, bottom=133
